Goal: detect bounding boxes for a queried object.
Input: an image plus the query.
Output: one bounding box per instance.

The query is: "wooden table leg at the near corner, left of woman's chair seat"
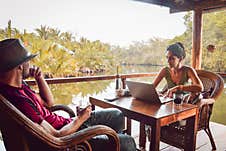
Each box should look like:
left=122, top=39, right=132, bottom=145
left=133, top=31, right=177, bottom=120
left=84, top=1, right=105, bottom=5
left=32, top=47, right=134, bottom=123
left=149, top=121, right=161, bottom=151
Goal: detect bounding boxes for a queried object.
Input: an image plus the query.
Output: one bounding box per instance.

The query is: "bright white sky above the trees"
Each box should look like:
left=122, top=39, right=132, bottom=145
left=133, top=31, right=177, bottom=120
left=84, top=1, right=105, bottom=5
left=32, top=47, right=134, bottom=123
left=0, top=0, right=185, bottom=46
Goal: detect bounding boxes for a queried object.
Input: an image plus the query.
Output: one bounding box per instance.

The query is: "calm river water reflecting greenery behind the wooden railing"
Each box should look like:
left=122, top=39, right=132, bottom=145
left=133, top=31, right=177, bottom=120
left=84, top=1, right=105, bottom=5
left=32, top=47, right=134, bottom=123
left=46, top=66, right=226, bottom=125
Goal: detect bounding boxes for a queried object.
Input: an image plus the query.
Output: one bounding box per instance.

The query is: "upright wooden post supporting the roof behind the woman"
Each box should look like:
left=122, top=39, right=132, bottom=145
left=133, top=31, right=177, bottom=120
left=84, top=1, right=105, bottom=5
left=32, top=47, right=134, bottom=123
left=191, top=9, right=202, bottom=69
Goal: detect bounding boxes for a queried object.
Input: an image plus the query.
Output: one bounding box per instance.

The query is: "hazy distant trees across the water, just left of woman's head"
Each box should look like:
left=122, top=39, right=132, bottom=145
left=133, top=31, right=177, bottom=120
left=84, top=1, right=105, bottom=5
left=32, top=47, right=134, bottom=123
left=112, top=38, right=168, bottom=65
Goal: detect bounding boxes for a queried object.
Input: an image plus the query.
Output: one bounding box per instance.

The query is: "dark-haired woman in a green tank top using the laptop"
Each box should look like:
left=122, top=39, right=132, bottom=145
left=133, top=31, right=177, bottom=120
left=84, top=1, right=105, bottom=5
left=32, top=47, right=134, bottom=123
left=153, top=42, right=203, bottom=103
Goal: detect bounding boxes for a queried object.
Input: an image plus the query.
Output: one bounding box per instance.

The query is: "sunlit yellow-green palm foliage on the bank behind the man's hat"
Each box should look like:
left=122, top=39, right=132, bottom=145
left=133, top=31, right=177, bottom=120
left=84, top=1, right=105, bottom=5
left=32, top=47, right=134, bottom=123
left=0, top=23, right=115, bottom=77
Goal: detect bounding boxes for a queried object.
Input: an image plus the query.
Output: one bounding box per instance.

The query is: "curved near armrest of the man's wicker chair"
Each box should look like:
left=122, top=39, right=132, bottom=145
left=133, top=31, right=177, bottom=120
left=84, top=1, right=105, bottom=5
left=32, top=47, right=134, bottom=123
left=60, top=125, right=120, bottom=151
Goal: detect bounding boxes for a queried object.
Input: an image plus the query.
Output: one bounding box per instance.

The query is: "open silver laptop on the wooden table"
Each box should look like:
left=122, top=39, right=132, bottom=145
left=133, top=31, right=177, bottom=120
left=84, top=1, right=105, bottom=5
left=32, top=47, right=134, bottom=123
left=126, top=81, right=173, bottom=104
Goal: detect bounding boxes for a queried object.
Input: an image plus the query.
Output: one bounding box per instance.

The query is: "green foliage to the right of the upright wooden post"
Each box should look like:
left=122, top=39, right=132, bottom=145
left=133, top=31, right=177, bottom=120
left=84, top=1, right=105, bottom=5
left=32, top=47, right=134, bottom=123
left=202, top=11, right=226, bottom=72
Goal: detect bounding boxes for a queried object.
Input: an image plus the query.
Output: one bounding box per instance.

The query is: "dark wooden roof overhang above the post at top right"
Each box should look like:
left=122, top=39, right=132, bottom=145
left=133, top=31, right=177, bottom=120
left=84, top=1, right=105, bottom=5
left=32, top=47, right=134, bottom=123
left=135, top=0, right=226, bottom=13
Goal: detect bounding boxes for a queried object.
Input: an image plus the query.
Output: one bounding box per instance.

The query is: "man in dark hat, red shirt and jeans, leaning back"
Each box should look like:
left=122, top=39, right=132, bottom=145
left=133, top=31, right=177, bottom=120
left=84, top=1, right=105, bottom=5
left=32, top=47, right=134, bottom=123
left=0, top=39, right=136, bottom=151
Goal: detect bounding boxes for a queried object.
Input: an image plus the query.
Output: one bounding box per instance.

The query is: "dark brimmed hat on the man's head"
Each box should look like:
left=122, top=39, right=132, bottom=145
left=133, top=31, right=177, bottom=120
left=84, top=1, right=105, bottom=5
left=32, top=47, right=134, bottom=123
left=0, top=39, right=37, bottom=72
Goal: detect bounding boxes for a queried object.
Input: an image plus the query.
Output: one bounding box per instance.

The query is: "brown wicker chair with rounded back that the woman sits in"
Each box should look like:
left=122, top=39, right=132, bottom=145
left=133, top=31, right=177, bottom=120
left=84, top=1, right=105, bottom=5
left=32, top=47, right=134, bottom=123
left=140, top=70, right=224, bottom=150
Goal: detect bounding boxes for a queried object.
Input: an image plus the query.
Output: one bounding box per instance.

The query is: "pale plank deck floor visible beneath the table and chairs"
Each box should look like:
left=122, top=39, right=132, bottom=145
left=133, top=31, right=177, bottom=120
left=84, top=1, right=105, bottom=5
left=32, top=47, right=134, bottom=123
left=0, top=121, right=226, bottom=151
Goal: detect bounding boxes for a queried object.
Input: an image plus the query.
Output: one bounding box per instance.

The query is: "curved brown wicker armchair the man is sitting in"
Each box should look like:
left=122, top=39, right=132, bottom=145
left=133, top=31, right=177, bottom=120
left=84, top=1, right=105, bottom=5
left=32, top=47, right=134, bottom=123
left=0, top=95, right=119, bottom=151
